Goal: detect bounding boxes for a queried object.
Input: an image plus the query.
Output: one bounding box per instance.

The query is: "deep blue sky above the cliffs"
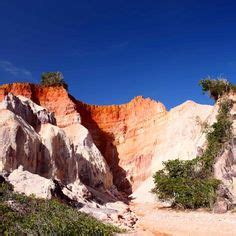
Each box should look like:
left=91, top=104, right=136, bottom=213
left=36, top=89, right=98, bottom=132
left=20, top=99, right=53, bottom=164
left=0, top=0, right=236, bottom=108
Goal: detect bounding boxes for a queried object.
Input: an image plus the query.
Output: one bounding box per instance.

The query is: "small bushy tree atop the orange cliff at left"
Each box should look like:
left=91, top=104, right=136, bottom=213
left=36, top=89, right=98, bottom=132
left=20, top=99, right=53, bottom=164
left=41, top=71, right=68, bottom=90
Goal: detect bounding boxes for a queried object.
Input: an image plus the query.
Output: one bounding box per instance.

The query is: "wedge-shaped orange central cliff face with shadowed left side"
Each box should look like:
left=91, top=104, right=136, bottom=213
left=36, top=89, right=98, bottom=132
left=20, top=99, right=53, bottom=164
left=77, top=97, right=166, bottom=191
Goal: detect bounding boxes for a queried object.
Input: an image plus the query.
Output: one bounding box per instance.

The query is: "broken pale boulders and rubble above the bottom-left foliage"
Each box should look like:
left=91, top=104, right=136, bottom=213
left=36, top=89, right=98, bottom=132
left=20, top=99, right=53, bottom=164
left=0, top=166, right=137, bottom=230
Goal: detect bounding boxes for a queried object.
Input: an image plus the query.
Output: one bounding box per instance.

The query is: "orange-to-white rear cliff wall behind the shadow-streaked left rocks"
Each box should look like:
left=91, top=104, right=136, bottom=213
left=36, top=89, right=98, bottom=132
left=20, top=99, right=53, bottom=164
left=0, top=84, right=216, bottom=193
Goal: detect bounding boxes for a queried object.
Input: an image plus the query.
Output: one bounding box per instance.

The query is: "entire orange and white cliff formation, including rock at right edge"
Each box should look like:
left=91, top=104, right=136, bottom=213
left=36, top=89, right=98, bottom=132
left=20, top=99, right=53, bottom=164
left=0, top=84, right=236, bottom=227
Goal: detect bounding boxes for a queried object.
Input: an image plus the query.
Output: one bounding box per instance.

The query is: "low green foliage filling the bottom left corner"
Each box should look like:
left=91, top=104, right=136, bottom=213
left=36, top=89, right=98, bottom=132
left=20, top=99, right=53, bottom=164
left=0, top=183, right=122, bottom=235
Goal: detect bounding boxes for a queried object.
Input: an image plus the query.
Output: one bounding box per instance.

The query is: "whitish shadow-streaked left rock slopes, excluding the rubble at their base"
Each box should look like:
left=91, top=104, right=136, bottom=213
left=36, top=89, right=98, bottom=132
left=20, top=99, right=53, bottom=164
left=0, top=93, right=113, bottom=189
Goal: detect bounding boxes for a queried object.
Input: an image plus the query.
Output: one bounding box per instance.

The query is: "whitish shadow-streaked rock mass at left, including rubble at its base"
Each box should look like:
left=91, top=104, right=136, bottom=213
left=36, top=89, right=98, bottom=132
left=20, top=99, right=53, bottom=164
left=0, top=93, right=137, bottom=228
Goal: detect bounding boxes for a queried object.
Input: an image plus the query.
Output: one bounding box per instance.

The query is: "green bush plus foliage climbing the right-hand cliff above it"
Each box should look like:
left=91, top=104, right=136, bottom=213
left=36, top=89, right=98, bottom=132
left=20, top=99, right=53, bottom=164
left=153, top=81, right=233, bottom=209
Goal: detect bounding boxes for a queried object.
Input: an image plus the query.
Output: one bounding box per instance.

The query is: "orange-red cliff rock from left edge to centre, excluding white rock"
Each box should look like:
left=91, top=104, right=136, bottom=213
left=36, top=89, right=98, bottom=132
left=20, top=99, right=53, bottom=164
left=0, top=83, right=167, bottom=192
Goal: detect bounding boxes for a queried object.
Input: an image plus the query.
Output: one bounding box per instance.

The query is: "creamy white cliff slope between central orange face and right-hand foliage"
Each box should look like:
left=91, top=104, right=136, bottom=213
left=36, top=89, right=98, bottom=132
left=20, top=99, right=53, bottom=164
left=132, top=101, right=218, bottom=203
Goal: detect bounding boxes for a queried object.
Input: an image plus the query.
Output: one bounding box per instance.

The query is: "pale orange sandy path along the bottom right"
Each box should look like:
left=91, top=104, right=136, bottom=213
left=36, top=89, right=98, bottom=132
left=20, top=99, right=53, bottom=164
left=131, top=203, right=236, bottom=236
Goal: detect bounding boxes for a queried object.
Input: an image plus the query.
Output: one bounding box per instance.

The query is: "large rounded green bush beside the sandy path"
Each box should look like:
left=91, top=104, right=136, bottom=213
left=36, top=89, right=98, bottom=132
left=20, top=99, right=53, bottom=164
left=153, top=165, right=220, bottom=209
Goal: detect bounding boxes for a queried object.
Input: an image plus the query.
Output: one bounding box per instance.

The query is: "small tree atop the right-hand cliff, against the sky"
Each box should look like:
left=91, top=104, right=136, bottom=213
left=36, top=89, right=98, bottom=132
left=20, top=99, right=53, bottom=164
left=199, top=77, right=232, bottom=101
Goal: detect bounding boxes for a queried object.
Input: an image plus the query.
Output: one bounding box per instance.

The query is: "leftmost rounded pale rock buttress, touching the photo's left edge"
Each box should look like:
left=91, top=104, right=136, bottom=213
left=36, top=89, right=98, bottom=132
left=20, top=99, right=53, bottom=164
left=0, top=109, right=43, bottom=173
